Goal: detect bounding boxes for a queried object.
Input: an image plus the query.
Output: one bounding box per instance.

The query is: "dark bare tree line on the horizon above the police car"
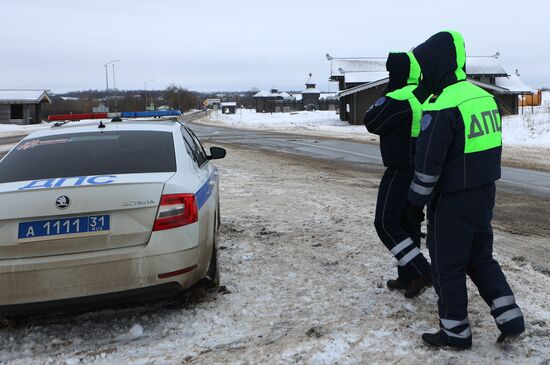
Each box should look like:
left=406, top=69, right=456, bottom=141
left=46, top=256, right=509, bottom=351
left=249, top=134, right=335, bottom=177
left=43, top=85, right=202, bottom=117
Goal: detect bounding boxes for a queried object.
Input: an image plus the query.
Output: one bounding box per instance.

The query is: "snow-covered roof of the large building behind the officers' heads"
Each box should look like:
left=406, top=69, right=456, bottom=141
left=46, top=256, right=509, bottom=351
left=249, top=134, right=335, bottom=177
left=330, top=56, right=508, bottom=79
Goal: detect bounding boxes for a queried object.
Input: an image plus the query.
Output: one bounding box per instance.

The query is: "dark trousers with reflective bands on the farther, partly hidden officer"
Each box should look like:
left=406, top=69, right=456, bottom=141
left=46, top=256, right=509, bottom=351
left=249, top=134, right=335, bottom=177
left=374, top=167, right=430, bottom=283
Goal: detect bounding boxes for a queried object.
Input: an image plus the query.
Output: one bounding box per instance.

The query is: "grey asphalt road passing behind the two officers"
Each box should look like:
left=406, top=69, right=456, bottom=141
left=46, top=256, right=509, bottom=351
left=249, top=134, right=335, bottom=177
left=188, top=123, right=550, bottom=198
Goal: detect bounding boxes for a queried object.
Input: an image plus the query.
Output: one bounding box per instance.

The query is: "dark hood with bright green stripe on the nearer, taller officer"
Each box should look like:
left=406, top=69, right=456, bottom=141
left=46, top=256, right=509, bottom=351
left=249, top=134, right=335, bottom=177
left=413, top=31, right=466, bottom=95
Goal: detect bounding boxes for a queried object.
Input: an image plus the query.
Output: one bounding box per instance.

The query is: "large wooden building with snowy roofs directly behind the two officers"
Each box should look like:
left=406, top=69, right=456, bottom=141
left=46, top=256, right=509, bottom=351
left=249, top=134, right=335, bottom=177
left=327, top=54, right=532, bottom=124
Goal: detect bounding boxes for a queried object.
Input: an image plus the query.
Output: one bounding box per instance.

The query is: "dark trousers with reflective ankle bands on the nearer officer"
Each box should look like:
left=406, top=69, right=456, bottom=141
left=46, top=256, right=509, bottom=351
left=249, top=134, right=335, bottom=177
left=428, top=183, right=524, bottom=342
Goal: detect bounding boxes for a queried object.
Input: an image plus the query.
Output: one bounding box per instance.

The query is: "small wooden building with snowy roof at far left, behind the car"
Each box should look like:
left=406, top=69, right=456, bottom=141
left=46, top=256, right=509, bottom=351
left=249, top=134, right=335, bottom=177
left=0, top=90, right=51, bottom=124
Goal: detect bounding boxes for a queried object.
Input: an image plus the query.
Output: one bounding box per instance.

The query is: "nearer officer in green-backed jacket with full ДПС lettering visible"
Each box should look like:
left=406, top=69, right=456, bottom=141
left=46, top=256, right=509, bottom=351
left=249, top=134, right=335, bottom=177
left=409, top=31, right=525, bottom=349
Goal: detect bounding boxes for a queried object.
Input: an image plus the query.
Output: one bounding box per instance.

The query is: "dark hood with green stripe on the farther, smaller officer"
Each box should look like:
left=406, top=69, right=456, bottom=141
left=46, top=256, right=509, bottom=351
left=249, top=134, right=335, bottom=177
left=386, top=52, right=420, bottom=92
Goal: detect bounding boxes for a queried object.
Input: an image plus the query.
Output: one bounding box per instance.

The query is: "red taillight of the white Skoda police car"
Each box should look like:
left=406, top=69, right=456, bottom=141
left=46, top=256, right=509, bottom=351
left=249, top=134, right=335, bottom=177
left=153, top=194, right=199, bottom=231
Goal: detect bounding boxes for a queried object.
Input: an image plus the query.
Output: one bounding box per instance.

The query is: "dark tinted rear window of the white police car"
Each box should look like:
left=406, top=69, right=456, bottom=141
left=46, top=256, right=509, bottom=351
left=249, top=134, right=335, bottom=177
left=0, top=131, right=176, bottom=183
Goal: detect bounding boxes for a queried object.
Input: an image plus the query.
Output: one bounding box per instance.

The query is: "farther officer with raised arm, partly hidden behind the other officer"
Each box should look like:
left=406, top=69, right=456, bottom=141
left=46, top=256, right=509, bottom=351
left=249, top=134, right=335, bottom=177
left=364, top=52, right=431, bottom=298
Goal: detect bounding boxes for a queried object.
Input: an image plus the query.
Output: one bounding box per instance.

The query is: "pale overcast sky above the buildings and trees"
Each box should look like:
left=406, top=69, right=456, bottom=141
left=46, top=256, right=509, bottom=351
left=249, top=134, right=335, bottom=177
left=0, top=0, right=550, bottom=92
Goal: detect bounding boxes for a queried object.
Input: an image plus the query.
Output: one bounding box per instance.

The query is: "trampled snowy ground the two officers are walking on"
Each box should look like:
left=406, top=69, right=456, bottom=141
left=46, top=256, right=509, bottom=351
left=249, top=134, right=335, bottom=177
left=0, top=147, right=550, bottom=365
